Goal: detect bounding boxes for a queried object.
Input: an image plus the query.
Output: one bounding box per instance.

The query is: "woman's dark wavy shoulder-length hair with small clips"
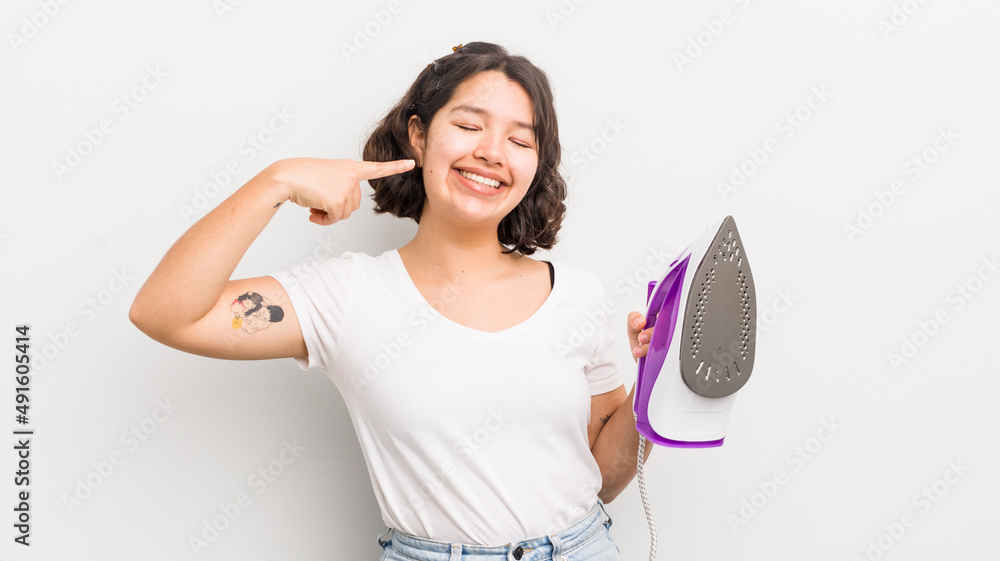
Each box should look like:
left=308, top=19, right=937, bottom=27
left=363, top=42, right=566, bottom=255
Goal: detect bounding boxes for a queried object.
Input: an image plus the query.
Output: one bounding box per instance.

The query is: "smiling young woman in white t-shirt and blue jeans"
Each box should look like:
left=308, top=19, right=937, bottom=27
left=130, top=43, right=652, bottom=561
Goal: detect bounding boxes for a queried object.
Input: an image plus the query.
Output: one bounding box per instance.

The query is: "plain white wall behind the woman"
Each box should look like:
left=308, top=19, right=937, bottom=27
left=0, top=0, right=1000, bottom=561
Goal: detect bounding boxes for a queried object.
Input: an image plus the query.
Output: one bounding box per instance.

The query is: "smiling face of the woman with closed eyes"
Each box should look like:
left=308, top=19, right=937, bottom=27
left=409, top=71, right=538, bottom=232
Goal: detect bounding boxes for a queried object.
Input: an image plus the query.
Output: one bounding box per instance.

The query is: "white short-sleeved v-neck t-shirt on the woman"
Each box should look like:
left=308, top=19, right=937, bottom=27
left=271, top=250, right=623, bottom=546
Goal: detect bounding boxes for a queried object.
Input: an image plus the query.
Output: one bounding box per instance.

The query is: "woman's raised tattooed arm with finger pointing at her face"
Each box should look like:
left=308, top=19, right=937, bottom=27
left=129, top=158, right=413, bottom=360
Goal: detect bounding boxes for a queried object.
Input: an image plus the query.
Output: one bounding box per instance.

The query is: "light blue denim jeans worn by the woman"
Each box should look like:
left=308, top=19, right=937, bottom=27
left=378, top=501, right=621, bottom=561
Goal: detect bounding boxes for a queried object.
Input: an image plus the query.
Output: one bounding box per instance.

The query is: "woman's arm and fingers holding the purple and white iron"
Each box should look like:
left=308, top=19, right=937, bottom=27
left=587, top=312, right=653, bottom=503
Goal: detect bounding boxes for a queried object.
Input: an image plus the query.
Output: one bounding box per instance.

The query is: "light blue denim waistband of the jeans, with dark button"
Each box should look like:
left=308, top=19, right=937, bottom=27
left=378, top=500, right=611, bottom=561
